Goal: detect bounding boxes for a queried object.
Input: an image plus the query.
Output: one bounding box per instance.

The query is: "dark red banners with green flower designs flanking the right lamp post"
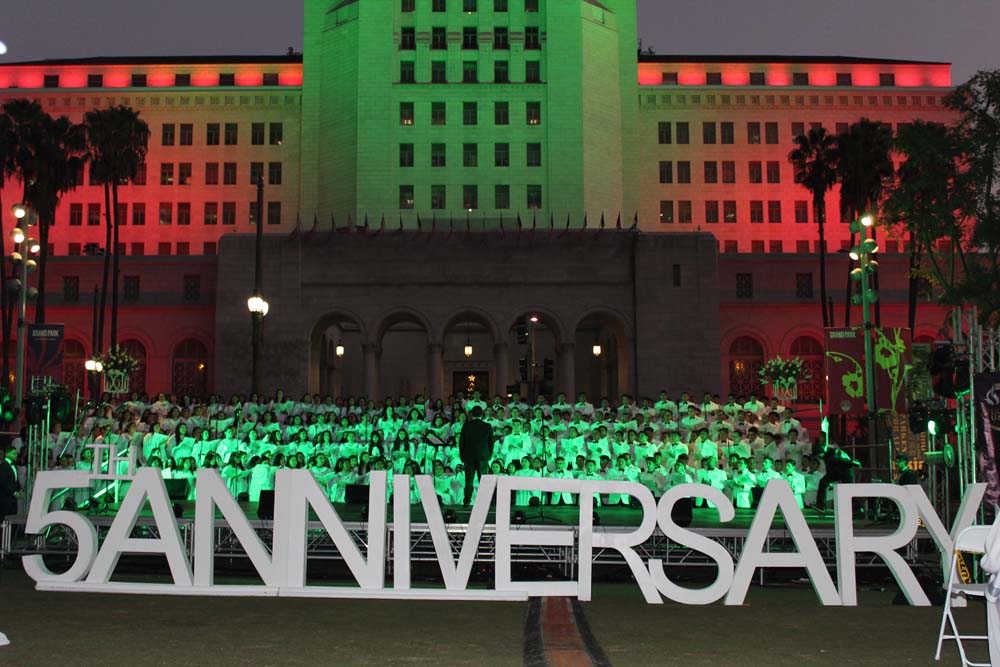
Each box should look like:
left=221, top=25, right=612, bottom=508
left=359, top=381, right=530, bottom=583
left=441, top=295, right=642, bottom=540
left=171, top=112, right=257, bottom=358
left=826, top=327, right=912, bottom=415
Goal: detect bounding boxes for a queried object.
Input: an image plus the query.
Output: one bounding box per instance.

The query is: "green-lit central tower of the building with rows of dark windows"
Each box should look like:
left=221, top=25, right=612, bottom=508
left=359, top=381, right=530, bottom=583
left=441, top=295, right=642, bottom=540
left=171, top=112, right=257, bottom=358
left=301, top=0, right=638, bottom=229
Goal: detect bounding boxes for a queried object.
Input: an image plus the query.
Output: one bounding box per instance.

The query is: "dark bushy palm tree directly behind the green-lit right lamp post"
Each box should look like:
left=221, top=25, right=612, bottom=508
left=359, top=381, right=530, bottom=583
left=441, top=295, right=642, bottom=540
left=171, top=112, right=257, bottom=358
left=837, top=118, right=894, bottom=326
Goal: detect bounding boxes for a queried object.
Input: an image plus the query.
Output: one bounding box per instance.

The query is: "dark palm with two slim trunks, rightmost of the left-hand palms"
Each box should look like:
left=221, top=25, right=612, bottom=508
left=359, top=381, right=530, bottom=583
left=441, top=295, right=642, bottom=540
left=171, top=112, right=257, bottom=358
left=84, top=106, right=149, bottom=349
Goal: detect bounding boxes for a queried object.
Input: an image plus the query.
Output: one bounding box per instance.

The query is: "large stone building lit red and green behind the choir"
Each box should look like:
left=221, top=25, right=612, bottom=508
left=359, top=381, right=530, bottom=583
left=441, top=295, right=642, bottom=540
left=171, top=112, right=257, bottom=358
left=0, top=0, right=951, bottom=396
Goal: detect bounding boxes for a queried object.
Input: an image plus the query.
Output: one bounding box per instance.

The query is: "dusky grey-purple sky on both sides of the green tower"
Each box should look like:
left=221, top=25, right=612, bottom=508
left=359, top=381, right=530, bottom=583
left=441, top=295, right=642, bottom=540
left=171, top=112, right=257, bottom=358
left=0, top=0, right=1000, bottom=83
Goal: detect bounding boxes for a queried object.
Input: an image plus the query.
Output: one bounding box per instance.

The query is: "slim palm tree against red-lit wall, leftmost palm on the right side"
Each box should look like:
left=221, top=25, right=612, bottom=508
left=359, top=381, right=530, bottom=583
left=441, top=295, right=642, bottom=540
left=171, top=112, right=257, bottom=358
left=788, top=127, right=837, bottom=329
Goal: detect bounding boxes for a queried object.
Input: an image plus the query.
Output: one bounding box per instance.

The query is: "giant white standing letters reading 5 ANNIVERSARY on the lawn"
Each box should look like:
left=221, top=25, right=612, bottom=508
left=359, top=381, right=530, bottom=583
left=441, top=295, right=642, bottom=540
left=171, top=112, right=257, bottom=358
left=23, top=463, right=985, bottom=606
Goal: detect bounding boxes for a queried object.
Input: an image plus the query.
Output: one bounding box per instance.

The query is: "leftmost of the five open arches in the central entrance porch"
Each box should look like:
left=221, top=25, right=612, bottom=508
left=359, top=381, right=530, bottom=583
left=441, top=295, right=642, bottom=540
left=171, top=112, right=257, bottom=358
left=309, top=312, right=368, bottom=396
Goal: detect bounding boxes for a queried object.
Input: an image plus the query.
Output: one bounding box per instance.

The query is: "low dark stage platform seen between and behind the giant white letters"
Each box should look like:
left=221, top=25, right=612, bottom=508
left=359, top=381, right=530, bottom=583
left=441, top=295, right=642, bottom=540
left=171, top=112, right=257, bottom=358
left=0, top=502, right=928, bottom=583
